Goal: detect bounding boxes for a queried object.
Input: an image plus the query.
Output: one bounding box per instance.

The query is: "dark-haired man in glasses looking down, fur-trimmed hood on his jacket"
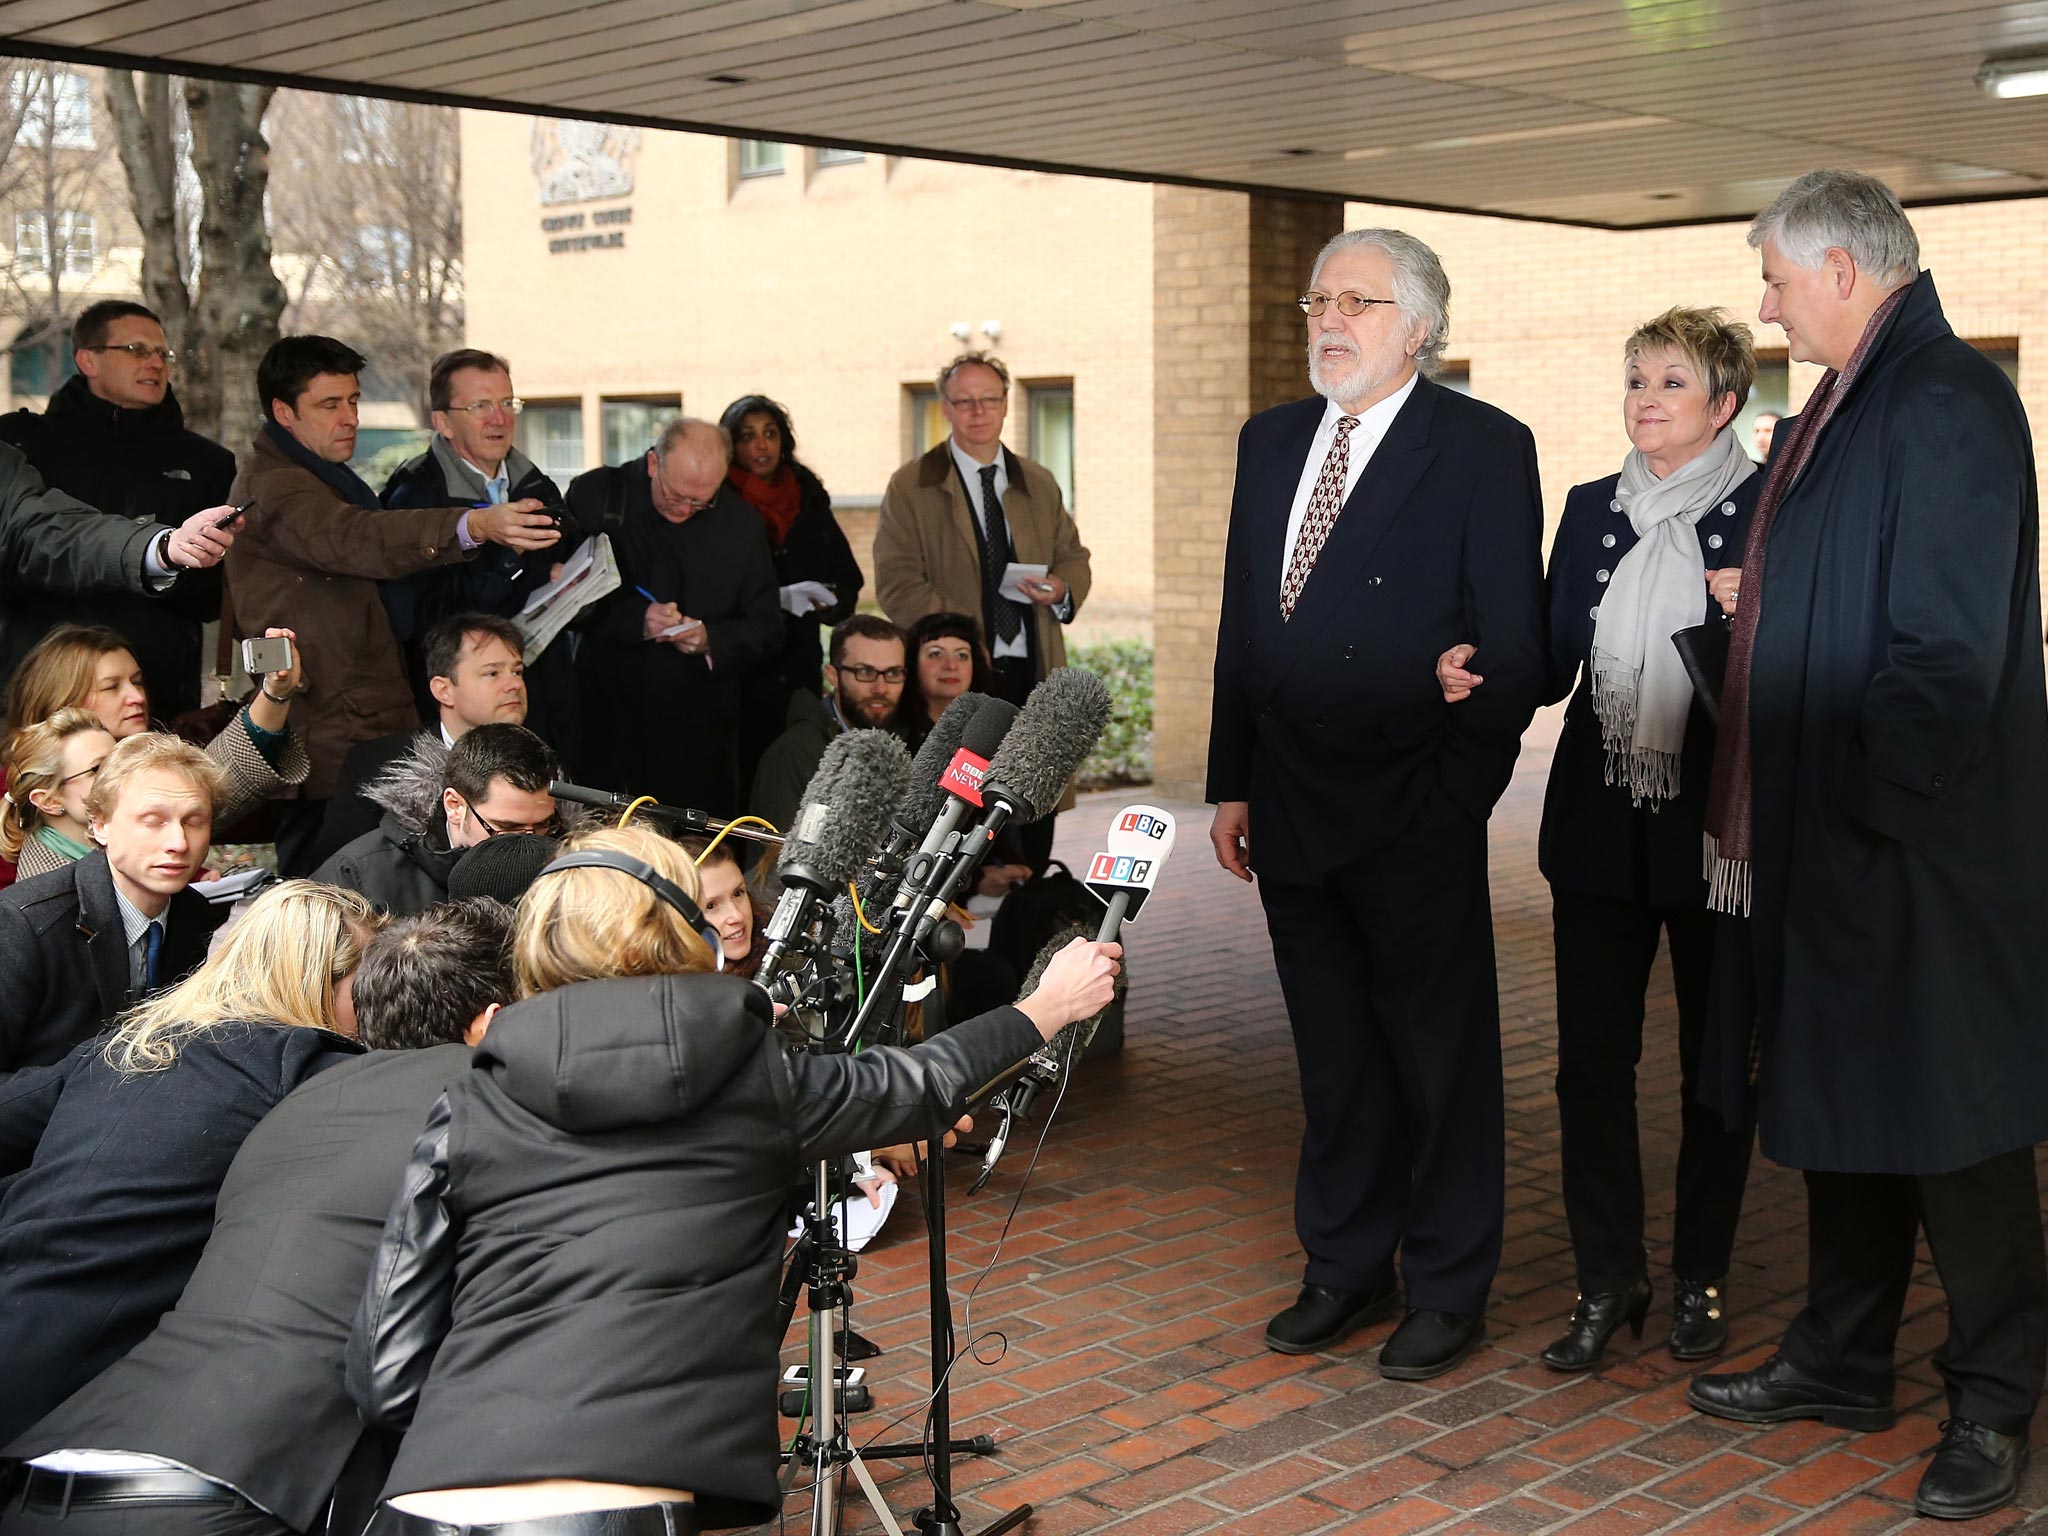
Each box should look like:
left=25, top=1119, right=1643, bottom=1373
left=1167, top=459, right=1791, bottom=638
left=313, top=725, right=561, bottom=918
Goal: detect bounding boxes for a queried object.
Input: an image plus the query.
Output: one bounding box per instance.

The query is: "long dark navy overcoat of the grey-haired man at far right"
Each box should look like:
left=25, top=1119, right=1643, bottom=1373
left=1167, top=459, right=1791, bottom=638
left=1718, top=272, right=2048, bottom=1174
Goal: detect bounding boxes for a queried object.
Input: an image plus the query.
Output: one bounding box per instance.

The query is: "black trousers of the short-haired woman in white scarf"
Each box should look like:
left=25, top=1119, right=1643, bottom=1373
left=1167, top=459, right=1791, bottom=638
left=1550, top=889, right=1755, bottom=1296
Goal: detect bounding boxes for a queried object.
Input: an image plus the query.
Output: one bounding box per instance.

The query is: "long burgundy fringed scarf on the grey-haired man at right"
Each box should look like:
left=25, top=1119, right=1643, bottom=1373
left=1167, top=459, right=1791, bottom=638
left=1706, top=283, right=1913, bottom=918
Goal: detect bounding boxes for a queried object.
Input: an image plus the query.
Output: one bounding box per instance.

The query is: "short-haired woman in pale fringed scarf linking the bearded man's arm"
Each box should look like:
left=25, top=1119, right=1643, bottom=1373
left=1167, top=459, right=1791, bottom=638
left=1438, top=309, right=1763, bottom=1370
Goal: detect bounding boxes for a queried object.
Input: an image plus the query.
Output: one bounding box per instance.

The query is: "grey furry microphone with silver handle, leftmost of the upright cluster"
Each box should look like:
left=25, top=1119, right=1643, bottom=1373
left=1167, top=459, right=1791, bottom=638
left=756, top=731, right=909, bottom=987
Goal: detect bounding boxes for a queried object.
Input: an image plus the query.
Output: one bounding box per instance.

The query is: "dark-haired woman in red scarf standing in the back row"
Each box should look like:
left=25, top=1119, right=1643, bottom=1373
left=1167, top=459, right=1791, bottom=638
left=719, top=395, right=864, bottom=784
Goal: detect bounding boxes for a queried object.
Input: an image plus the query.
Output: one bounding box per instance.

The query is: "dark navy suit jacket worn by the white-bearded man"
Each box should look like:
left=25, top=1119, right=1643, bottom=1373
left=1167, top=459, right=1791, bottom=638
left=1208, top=379, right=1546, bottom=883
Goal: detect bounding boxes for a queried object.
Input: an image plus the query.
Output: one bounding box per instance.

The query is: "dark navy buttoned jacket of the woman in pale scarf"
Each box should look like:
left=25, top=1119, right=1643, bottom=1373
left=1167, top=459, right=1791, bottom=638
left=1540, top=471, right=1763, bottom=907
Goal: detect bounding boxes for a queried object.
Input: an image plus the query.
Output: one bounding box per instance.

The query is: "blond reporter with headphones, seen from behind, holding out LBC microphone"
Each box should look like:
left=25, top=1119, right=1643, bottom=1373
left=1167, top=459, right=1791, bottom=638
left=348, top=827, right=1120, bottom=1536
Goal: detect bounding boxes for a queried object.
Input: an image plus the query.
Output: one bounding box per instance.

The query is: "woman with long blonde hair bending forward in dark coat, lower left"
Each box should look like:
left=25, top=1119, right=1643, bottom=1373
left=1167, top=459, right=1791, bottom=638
left=0, top=881, right=379, bottom=1444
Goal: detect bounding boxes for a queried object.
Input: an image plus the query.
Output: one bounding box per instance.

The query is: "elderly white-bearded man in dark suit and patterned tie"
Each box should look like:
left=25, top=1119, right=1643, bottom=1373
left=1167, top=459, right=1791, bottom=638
left=1208, top=229, right=1544, bottom=1380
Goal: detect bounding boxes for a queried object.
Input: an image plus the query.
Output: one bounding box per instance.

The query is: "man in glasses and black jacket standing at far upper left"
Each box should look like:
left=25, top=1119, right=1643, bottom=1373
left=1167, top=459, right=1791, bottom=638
left=0, top=299, right=236, bottom=719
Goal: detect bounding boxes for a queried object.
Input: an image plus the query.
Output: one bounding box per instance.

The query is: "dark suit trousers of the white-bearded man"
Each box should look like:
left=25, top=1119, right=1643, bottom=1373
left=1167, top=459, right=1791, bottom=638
left=1253, top=807, right=1505, bottom=1313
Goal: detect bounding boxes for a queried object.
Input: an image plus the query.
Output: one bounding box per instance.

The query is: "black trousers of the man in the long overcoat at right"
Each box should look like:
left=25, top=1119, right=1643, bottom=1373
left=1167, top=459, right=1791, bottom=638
left=1780, top=1147, right=2048, bottom=1434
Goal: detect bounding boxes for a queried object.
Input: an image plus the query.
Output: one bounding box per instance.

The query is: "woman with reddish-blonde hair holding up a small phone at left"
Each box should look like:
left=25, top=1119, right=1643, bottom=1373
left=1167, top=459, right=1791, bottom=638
left=6, top=625, right=309, bottom=847
